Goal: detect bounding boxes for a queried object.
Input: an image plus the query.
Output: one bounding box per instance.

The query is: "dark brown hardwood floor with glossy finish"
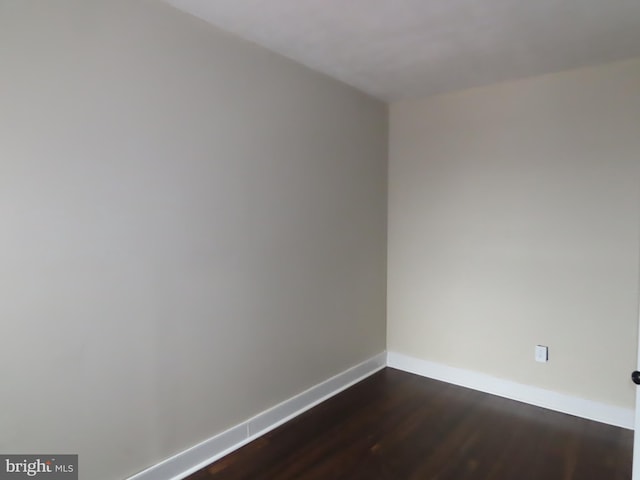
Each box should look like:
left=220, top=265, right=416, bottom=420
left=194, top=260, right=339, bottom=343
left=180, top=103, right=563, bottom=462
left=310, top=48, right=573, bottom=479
left=188, top=368, right=633, bottom=480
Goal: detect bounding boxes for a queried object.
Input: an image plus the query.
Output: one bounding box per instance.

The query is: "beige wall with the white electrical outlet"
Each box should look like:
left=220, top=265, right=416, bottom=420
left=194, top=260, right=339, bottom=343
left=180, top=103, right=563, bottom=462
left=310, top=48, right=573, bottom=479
left=387, top=59, right=640, bottom=408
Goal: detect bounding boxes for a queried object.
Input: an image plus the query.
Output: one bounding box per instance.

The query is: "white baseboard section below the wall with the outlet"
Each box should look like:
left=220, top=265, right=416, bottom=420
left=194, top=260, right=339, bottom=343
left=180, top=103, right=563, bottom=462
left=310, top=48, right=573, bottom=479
left=387, top=352, right=635, bottom=430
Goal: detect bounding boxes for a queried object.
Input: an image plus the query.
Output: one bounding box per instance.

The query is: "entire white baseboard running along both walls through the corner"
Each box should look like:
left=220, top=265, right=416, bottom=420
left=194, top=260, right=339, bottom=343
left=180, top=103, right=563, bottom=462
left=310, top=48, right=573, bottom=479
left=128, top=352, right=635, bottom=480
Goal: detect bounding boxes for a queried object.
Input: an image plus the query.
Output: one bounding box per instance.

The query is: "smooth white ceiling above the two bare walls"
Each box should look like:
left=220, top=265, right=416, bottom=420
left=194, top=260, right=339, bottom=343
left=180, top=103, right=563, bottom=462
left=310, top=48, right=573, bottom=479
left=166, top=0, right=640, bottom=101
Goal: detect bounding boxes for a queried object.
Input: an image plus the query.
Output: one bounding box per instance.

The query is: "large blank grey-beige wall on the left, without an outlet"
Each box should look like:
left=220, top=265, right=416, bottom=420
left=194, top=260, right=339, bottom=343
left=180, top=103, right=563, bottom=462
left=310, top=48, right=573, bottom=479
left=0, top=0, right=387, bottom=480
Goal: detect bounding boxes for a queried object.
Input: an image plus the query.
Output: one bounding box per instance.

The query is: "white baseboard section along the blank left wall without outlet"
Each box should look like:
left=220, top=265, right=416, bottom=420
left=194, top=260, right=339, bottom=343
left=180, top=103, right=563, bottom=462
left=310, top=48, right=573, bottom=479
left=128, top=352, right=387, bottom=480
